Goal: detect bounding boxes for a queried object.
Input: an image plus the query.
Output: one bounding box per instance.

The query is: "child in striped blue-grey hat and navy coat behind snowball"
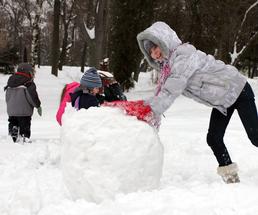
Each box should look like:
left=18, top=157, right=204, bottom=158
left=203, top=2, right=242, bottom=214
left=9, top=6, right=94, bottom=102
left=70, top=67, right=102, bottom=110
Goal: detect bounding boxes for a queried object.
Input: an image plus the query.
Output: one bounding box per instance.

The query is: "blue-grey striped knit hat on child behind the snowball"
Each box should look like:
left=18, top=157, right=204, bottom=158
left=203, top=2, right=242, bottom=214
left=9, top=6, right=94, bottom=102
left=80, top=67, right=102, bottom=89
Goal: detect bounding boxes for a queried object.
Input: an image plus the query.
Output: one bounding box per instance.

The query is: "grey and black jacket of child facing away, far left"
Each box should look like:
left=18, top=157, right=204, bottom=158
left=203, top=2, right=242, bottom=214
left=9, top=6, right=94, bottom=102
left=5, top=73, right=41, bottom=116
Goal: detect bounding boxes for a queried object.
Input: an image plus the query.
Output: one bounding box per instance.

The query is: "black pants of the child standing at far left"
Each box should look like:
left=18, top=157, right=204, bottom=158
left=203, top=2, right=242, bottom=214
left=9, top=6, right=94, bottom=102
left=8, top=116, right=31, bottom=138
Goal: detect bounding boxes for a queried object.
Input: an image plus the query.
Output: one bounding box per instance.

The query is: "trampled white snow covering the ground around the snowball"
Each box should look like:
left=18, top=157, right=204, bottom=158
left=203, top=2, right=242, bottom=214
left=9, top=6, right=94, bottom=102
left=0, top=67, right=258, bottom=215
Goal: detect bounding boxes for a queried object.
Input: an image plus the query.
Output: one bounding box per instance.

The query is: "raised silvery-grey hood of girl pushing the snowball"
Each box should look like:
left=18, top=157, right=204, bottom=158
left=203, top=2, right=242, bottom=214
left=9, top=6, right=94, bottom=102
left=137, top=22, right=182, bottom=69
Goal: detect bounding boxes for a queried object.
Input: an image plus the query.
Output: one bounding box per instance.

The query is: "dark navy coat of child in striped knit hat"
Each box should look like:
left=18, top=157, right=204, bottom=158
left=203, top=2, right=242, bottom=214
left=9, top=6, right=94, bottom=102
left=70, top=88, right=100, bottom=110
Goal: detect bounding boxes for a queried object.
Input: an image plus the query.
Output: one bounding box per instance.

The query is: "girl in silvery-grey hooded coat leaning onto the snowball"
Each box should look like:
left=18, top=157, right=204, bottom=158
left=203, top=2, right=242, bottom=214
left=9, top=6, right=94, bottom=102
left=137, top=22, right=258, bottom=183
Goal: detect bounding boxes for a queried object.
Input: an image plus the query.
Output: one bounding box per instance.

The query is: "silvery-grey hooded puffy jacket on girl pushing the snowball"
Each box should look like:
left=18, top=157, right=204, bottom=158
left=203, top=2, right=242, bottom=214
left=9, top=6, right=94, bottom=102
left=137, top=22, right=246, bottom=115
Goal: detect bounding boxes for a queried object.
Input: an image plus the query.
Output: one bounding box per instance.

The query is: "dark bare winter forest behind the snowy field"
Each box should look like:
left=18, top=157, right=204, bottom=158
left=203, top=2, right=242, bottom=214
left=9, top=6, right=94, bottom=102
left=0, top=0, right=258, bottom=89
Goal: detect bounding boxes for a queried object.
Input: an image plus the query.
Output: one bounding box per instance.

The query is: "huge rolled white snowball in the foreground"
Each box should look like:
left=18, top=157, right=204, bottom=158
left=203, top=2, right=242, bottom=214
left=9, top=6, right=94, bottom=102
left=61, top=107, right=163, bottom=203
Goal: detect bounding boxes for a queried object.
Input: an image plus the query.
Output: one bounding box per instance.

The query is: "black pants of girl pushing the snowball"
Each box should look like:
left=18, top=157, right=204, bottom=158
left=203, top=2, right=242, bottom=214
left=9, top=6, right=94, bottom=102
left=207, top=83, right=258, bottom=166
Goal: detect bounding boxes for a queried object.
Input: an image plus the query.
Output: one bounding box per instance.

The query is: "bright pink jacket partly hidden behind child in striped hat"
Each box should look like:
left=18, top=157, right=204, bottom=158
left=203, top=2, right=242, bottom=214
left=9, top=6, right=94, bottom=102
left=56, top=82, right=80, bottom=125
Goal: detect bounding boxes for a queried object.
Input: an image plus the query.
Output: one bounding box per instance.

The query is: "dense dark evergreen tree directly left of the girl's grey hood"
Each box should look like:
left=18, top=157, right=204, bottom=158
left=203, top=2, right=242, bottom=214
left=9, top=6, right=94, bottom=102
left=109, top=0, right=154, bottom=90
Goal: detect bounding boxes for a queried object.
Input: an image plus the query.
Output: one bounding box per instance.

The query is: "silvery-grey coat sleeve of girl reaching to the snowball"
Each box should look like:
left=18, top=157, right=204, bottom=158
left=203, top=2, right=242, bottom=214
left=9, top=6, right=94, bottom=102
left=146, top=53, right=200, bottom=115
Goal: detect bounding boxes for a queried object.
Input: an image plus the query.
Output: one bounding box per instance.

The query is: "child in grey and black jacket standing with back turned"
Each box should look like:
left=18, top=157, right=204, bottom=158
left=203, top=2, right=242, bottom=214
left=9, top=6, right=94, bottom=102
left=5, top=63, right=42, bottom=143
